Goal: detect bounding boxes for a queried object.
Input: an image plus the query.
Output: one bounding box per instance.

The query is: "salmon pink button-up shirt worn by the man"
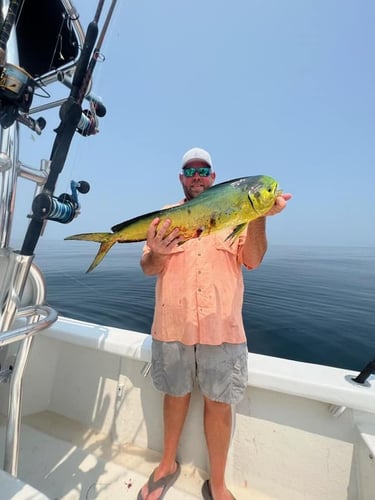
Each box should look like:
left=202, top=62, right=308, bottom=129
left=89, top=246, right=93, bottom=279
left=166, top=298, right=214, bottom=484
left=143, top=221, right=250, bottom=345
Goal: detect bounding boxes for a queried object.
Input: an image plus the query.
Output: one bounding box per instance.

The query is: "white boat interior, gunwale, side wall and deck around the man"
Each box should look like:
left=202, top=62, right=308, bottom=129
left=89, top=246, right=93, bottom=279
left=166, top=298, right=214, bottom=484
left=0, top=318, right=375, bottom=500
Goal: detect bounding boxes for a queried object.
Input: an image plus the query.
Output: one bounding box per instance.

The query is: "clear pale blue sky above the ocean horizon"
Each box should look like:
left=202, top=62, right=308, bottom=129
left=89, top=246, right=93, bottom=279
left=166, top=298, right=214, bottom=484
left=14, top=0, right=375, bottom=251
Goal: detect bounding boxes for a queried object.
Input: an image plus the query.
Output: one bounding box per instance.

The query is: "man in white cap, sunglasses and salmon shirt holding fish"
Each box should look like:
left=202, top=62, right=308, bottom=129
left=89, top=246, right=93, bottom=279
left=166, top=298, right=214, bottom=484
left=138, top=148, right=291, bottom=500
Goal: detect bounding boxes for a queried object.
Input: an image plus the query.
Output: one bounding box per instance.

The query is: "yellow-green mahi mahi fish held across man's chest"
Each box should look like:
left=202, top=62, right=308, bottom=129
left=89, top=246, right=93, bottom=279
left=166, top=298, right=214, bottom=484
left=65, top=175, right=281, bottom=272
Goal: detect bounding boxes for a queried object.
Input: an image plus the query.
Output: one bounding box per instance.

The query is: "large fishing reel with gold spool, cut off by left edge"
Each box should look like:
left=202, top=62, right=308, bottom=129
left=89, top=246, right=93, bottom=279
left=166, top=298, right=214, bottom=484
left=0, top=64, right=35, bottom=128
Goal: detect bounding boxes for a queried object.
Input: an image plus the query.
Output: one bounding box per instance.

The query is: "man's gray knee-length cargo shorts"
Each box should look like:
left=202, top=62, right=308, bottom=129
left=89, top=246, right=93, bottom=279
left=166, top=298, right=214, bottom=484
left=151, top=339, right=248, bottom=404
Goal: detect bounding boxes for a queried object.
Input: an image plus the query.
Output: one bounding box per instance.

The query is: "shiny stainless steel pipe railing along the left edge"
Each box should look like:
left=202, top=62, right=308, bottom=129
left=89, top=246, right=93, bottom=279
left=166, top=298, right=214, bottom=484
left=0, top=0, right=84, bottom=476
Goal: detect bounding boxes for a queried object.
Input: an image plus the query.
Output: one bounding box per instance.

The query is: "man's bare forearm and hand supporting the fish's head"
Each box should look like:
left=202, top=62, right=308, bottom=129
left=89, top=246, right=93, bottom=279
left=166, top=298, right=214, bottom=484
left=242, top=193, right=292, bottom=269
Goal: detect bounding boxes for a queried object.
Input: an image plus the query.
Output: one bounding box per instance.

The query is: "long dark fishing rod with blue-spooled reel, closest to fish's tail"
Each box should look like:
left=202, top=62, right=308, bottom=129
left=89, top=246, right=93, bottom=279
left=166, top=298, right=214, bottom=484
left=20, top=0, right=117, bottom=256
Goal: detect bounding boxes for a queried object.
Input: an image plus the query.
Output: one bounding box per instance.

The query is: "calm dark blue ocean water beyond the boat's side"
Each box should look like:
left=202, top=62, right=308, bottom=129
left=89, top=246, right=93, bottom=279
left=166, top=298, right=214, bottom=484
left=35, top=241, right=375, bottom=370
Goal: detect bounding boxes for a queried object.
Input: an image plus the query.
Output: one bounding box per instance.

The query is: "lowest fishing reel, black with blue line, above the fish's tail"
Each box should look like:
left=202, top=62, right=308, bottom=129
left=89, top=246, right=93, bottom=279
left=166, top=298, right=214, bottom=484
left=32, top=181, right=90, bottom=224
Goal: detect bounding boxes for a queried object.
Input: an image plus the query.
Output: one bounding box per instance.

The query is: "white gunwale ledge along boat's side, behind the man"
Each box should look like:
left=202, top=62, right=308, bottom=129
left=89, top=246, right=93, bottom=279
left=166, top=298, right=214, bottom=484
left=41, top=316, right=375, bottom=413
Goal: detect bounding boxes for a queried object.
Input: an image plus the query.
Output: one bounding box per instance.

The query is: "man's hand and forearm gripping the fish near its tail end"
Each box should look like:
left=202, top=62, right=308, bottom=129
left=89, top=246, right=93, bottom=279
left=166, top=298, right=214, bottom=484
left=141, top=217, right=180, bottom=276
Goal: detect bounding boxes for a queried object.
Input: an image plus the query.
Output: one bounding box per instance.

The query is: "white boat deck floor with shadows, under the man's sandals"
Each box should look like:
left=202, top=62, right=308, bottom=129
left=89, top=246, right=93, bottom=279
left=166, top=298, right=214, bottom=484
left=0, top=411, right=268, bottom=500
